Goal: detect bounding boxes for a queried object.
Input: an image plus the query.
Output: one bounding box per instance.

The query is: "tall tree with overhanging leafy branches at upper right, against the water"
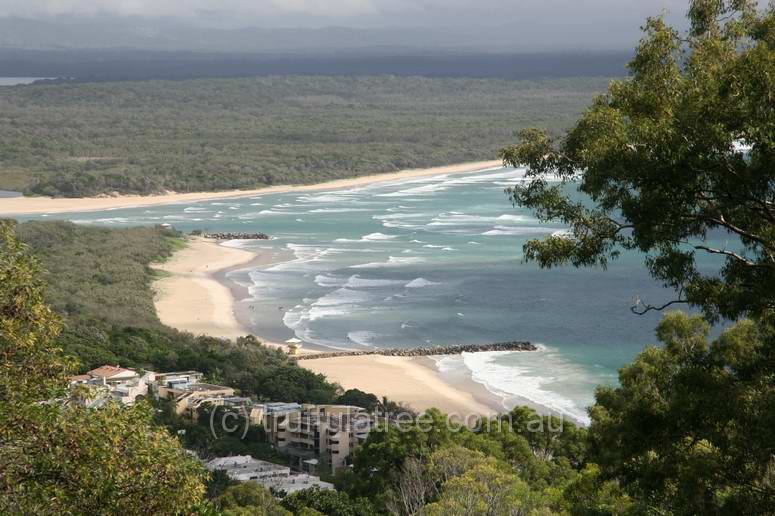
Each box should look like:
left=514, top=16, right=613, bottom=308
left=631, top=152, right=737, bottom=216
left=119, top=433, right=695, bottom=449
left=501, top=0, right=775, bottom=320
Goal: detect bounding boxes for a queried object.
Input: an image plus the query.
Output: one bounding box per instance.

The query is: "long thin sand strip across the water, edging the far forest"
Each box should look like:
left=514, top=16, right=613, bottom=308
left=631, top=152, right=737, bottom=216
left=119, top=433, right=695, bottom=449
left=0, top=160, right=503, bottom=215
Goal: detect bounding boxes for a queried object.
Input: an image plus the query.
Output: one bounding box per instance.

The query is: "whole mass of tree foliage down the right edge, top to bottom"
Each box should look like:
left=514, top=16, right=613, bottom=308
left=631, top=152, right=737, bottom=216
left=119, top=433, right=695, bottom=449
left=502, top=0, right=775, bottom=514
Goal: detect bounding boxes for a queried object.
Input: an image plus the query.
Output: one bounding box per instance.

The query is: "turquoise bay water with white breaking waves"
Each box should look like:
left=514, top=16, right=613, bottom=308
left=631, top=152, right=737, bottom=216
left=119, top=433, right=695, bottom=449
left=16, top=169, right=720, bottom=421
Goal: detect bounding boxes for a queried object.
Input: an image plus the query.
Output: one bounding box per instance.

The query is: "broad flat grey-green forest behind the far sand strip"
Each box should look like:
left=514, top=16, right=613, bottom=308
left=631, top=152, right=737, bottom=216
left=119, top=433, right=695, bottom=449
left=0, top=76, right=607, bottom=197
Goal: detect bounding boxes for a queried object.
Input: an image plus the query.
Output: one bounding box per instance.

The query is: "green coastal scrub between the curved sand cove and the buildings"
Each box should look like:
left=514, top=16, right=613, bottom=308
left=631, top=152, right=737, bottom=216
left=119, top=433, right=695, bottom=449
left=9, top=222, right=337, bottom=403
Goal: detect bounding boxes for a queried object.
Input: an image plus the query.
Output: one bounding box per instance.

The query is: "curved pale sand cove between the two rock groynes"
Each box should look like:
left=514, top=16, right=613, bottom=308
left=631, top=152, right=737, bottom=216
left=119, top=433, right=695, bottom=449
left=153, top=238, right=271, bottom=339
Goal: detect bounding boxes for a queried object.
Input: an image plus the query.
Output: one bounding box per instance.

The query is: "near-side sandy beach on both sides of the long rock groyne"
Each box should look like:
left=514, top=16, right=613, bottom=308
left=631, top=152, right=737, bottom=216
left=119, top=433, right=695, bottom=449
left=153, top=238, right=510, bottom=418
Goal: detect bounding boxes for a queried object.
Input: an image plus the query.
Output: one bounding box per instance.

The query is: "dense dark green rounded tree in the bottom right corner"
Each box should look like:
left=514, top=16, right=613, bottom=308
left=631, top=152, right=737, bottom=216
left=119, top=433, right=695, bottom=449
left=590, top=312, right=775, bottom=514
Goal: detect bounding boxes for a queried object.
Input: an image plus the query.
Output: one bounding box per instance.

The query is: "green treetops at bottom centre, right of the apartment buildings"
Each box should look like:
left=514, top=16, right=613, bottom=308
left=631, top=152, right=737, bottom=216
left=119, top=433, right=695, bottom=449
left=340, top=407, right=586, bottom=515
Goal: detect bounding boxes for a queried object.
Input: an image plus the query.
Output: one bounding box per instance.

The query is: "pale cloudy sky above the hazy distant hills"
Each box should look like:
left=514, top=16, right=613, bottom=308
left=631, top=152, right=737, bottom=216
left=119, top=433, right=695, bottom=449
left=0, top=0, right=688, bottom=31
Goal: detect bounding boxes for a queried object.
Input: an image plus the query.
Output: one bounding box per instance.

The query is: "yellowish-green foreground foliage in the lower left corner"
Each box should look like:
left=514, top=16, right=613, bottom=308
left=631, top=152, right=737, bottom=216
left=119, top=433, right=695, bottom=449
left=0, top=222, right=205, bottom=514
